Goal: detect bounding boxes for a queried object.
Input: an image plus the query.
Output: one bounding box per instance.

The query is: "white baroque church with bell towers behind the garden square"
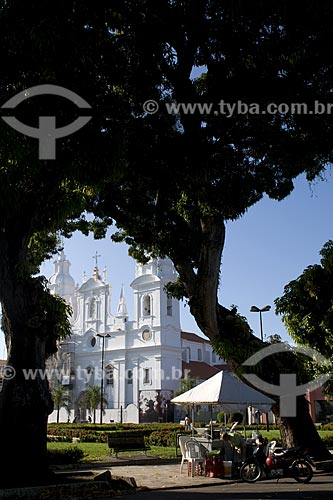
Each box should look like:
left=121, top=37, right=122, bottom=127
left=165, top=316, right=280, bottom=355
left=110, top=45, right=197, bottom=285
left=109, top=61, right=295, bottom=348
left=49, top=251, right=225, bottom=423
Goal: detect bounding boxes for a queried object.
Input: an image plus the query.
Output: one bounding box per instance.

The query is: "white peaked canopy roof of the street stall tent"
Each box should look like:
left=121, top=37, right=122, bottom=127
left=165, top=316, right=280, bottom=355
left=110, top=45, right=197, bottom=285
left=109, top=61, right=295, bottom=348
left=171, top=371, right=275, bottom=434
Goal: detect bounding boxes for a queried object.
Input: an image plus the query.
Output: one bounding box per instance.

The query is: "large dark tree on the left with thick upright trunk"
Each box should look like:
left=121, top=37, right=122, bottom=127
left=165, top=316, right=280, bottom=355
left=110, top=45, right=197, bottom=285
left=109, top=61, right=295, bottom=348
left=0, top=1, right=125, bottom=486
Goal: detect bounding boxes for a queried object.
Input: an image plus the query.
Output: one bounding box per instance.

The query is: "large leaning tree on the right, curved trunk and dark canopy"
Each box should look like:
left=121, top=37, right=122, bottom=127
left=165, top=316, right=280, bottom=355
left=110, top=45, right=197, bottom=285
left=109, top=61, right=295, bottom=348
left=87, top=1, right=333, bottom=457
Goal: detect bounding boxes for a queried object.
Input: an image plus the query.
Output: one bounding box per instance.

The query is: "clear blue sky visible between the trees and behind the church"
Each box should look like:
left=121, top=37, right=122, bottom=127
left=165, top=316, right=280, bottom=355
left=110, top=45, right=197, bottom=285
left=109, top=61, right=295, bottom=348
left=0, top=173, right=333, bottom=357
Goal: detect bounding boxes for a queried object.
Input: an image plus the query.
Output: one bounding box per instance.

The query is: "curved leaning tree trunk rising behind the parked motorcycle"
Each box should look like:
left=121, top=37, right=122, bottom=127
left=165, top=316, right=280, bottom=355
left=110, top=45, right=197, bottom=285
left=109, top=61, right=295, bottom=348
left=173, top=217, right=331, bottom=460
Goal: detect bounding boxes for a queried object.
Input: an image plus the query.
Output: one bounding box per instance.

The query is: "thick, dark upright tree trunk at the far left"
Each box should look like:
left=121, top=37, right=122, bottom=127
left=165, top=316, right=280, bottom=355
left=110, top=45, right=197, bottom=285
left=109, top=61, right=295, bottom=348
left=0, top=271, right=53, bottom=488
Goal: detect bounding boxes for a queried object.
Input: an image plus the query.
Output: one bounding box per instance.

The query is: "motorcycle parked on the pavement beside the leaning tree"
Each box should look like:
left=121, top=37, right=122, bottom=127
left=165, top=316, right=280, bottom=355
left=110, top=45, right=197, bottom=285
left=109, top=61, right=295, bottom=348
left=239, top=440, right=315, bottom=483
